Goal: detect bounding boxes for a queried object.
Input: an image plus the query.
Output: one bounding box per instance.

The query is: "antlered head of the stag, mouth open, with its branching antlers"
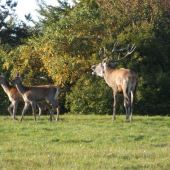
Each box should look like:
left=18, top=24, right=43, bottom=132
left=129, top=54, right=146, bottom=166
left=91, top=41, right=136, bottom=77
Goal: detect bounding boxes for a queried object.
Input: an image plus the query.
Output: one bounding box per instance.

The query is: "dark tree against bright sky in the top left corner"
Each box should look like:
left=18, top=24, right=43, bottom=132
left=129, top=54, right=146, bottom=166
left=0, top=0, right=34, bottom=47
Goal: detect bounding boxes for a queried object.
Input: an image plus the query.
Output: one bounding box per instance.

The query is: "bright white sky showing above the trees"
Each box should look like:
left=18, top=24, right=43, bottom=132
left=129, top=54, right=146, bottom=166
left=0, top=0, right=73, bottom=21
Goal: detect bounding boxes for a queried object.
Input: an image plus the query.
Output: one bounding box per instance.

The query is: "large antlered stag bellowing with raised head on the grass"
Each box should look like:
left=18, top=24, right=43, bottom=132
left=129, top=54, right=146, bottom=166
left=91, top=42, right=138, bottom=120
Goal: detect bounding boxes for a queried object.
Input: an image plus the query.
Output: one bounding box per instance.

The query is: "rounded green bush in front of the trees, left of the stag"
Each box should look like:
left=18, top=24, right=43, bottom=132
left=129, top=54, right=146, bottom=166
left=66, top=75, right=113, bottom=115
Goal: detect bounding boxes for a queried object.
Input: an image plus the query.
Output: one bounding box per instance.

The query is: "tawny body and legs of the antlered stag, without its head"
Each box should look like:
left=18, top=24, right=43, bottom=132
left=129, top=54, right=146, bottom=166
left=104, top=66, right=138, bottom=119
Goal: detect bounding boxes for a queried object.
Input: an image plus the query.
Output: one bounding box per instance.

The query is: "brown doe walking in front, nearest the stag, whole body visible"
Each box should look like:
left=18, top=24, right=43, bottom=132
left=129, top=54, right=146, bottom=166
left=10, top=74, right=60, bottom=122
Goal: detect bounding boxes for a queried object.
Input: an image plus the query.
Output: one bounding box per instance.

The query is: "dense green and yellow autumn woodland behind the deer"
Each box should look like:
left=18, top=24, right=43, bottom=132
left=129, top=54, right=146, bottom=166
left=0, top=0, right=170, bottom=115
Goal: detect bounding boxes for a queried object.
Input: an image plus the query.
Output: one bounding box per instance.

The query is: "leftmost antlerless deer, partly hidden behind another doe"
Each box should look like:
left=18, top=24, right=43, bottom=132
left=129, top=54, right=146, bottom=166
left=0, top=73, right=51, bottom=120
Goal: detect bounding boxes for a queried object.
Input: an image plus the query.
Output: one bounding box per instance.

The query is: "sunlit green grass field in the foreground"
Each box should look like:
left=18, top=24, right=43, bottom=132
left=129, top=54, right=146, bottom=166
left=0, top=115, right=170, bottom=170
